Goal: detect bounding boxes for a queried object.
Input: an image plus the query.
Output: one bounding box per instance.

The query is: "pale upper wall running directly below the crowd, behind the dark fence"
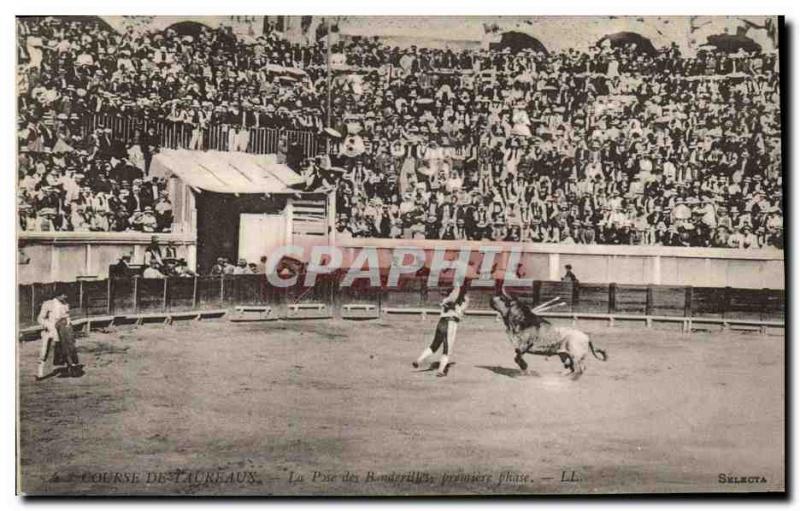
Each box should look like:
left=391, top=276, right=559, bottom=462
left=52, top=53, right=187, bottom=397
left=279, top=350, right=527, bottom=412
left=17, top=232, right=785, bottom=289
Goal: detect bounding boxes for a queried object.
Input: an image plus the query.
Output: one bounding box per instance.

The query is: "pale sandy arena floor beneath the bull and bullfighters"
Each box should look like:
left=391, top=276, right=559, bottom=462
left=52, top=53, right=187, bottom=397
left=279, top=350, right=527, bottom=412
left=19, top=318, right=785, bottom=495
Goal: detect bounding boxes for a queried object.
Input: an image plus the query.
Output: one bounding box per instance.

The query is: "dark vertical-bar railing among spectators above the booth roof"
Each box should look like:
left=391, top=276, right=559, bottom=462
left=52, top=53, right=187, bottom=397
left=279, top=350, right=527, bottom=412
left=83, top=112, right=319, bottom=157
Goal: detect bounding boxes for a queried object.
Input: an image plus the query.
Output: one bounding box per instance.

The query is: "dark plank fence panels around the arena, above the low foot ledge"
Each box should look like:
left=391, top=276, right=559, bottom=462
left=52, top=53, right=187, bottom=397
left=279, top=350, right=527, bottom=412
left=18, top=275, right=785, bottom=326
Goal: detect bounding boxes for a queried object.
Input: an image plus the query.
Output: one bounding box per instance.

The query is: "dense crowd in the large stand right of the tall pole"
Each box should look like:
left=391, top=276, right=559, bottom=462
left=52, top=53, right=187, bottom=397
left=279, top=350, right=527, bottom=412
left=318, top=38, right=783, bottom=248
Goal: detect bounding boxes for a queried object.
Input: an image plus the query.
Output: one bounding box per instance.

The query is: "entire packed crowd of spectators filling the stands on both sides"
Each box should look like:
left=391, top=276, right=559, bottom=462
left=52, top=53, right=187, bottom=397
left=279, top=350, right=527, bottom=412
left=19, top=18, right=783, bottom=251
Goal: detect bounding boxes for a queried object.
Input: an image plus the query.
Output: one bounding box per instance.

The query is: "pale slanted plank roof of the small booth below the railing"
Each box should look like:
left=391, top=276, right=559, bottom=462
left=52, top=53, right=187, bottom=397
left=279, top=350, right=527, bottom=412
left=150, top=149, right=304, bottom=193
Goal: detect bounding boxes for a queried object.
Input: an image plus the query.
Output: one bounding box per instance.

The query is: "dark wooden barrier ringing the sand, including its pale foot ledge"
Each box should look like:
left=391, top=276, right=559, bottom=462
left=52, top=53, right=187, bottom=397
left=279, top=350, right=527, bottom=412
left=17, top=273, right=786, bottom=338
